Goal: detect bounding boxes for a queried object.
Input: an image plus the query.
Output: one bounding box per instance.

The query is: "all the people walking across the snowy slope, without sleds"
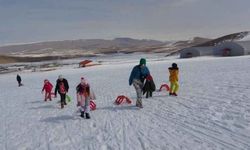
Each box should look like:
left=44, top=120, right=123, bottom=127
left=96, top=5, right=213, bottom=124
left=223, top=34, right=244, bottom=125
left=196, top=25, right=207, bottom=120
left=17, top=58, right=179, bottom=119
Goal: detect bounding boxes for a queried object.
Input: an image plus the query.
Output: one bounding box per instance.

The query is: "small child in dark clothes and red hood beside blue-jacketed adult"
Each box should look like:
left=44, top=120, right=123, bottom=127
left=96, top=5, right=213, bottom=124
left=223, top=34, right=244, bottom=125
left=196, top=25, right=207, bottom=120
left=142, top=75, right=155, bottom=98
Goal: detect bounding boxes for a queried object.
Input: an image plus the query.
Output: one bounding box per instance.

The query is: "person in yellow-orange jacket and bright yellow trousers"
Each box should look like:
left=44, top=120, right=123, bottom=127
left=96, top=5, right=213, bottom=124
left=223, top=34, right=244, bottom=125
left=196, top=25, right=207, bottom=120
left=168, top=63, right=179, bottom=96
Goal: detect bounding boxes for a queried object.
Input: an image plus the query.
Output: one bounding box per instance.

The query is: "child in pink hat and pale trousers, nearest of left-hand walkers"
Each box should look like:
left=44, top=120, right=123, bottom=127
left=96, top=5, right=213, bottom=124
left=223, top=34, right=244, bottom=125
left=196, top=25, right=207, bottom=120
left=76, top=77, right=95, bottom=119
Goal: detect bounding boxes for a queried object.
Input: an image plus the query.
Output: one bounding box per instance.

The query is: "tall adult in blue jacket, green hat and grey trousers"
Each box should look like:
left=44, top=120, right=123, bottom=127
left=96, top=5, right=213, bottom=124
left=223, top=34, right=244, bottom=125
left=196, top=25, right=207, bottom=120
left=129, top=58, right=150, bottom=108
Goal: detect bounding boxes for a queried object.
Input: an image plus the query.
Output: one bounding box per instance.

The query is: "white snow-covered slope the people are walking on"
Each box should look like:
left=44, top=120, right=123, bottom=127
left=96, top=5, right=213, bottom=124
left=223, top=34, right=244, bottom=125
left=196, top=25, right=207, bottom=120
left=0, top=56, right=250, bottom=150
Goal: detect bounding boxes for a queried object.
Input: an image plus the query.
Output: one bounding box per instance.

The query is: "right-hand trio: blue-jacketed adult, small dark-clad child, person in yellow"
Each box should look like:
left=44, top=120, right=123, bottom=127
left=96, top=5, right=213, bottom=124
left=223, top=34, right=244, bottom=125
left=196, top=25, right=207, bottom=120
left=129, top=58, right=179, bottom=108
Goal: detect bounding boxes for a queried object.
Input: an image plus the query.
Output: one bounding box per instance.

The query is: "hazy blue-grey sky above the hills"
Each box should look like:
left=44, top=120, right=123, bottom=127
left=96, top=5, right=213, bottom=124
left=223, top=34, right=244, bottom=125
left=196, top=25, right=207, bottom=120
left=0, top=0, right=250, bottom=45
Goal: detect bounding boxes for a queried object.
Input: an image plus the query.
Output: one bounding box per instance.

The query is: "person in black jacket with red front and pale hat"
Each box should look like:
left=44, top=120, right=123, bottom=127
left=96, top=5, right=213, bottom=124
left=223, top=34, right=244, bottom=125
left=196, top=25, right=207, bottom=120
left=55, top=75, right=69, bottom=108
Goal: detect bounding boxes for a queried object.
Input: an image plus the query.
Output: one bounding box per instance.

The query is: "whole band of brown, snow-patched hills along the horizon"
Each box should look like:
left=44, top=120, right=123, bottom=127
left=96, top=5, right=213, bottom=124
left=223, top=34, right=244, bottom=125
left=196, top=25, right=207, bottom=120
left=0, top=31, right=249, bottom=63
